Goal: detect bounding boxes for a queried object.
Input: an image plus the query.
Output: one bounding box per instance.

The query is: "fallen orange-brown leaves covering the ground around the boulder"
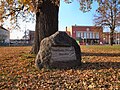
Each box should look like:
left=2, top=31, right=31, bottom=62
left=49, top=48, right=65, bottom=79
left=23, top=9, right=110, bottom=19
left=0, top=46, right=120, bottom=90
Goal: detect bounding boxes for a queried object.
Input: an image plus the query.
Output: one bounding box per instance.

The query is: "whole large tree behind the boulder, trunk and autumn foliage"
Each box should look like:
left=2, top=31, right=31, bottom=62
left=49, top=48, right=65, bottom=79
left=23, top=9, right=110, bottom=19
left=0, top=0, right=100, bottom=54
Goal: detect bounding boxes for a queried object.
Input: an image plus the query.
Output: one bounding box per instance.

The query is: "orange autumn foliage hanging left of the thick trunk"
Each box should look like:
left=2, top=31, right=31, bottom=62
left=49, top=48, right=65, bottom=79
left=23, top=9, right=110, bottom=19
left=0, top=0, right=35, bottom=26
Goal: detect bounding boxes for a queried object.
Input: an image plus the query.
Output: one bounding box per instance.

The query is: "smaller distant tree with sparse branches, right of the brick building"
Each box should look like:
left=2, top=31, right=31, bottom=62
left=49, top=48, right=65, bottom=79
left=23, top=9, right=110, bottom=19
left=94, top=0, right=120, bottom=45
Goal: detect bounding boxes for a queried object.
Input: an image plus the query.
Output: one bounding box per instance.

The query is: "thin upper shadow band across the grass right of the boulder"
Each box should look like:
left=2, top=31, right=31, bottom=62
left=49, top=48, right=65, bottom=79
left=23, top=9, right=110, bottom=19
left=82, top=52, right=120, bottom=57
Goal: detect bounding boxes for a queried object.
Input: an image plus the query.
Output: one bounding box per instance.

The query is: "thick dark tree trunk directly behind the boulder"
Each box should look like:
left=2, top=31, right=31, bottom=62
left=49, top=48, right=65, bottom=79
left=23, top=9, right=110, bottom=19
left=31, top=0, right=59, bottom=54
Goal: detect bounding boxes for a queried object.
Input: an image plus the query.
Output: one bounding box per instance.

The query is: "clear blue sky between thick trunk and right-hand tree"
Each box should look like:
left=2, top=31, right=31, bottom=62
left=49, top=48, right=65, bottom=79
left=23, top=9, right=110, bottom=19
left=59, top=0, right=97, bottom=30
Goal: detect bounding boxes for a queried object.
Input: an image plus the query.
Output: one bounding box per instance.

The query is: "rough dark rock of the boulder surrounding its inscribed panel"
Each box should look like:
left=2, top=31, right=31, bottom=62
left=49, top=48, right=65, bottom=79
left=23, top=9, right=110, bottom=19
left=35, top=31, right=81, bottom=69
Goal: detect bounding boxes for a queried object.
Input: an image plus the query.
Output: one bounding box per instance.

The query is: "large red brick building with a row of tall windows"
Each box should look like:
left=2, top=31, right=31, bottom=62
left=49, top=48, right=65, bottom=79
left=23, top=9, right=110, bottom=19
left=66, top=25, right=103, bottom=45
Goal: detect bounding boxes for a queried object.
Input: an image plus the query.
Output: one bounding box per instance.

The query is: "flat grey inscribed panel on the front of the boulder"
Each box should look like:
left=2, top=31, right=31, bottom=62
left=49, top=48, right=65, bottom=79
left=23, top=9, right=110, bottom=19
left=51, top=47, right=76, bottom=61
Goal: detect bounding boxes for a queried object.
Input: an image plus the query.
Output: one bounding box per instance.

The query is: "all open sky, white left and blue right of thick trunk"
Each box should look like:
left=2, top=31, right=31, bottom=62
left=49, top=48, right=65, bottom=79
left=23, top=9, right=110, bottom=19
left=10, top=0, right=97, bottom=39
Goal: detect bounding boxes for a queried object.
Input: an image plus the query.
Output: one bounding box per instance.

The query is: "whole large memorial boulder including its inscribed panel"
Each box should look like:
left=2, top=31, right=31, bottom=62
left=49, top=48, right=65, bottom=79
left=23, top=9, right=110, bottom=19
left=35, top=31, right=81, bottom=69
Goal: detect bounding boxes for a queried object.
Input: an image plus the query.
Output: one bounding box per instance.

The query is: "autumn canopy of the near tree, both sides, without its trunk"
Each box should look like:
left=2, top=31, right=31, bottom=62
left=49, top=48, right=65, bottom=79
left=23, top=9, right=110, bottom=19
left=0, top=0, right=100, bottom=22
